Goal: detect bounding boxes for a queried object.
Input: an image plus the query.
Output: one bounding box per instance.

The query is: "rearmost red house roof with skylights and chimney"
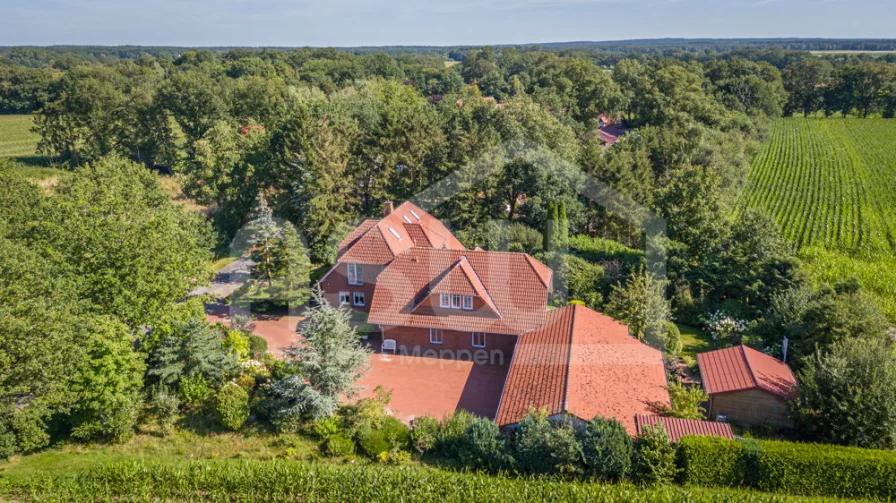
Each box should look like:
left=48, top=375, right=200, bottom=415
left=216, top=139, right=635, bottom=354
left=337, top=201, right=464, bottom=265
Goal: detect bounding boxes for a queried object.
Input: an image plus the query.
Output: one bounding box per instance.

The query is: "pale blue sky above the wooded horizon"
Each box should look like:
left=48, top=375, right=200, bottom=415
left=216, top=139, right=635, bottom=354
left=0, top=0, right=896, bottom=46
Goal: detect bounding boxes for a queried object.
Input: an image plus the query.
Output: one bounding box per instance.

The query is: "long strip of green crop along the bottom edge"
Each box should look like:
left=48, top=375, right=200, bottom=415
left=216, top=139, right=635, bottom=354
left=0, top=460, right=848, bottom=503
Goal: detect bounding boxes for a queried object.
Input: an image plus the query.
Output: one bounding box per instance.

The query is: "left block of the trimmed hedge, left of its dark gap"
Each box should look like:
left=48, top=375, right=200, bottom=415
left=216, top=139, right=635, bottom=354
left=677, top=436, right=748, bottom=486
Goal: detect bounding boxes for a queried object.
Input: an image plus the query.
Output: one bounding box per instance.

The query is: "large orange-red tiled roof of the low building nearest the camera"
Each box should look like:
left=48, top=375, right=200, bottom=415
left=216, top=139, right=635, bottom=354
left=496, top=305, right=670, bottom=434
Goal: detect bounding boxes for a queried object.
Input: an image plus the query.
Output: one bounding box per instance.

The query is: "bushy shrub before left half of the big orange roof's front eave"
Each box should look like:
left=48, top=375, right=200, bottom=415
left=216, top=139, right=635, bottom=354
left=514, top=411, right=584, bottom=474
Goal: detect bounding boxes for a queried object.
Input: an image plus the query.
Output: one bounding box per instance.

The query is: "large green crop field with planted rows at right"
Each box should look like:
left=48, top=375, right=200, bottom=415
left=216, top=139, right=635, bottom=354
left=742, top=119, right=896, bottom=319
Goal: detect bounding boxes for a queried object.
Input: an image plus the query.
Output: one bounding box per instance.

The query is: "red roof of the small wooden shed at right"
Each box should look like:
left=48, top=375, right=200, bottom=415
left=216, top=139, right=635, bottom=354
left=697, top=346, right=797, bottom=399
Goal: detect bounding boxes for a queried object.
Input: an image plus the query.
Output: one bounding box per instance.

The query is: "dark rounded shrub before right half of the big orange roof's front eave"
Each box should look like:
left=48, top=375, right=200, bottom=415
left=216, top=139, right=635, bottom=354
left=582, top=417, right=634, bottom=480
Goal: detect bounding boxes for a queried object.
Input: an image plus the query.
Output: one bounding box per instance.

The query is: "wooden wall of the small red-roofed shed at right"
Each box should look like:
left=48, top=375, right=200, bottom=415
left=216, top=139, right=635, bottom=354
left=709, top=389, right=793, bottom=427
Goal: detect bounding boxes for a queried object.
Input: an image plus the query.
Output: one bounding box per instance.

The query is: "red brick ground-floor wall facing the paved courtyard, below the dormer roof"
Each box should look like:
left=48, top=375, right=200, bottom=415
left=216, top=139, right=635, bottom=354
left=382, top=326, right=517, bottom=364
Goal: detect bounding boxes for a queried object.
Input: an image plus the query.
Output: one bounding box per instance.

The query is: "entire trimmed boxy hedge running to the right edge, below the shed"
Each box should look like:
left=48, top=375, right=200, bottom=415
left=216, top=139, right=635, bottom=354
left=678, top=437, right=896, bottom=500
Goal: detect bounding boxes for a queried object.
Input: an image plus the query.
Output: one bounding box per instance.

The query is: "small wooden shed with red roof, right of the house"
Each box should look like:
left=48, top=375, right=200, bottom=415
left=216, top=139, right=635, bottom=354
left=697, top=346, right=797, bottom=427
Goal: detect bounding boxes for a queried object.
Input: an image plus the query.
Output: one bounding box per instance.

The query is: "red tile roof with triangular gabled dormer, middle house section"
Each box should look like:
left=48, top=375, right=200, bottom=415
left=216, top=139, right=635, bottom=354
left=368, top=248, right=550, bottom=335
